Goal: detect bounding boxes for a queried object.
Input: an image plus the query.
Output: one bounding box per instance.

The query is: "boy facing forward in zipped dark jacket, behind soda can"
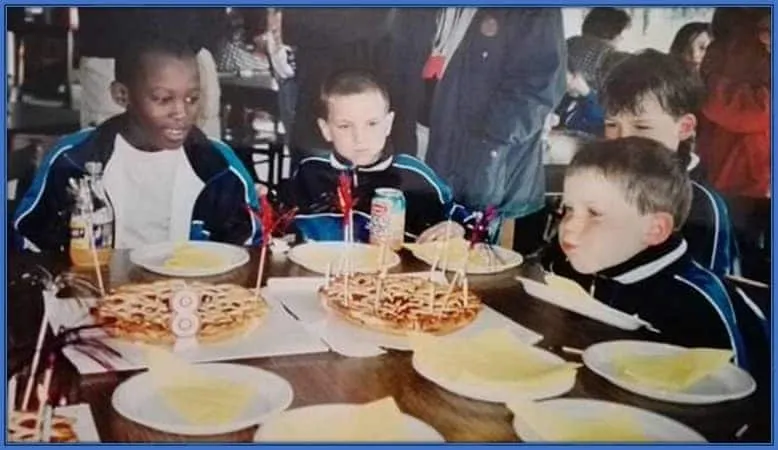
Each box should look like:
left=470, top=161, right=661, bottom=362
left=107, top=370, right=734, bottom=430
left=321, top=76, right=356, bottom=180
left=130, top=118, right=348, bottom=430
left=280, top=70, right=473, bottom=243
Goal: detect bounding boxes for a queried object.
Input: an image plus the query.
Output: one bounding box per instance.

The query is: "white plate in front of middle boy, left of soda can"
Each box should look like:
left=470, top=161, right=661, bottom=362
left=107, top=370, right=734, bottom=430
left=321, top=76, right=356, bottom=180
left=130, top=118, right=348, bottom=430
left=289, top=241, right=400, bottom=274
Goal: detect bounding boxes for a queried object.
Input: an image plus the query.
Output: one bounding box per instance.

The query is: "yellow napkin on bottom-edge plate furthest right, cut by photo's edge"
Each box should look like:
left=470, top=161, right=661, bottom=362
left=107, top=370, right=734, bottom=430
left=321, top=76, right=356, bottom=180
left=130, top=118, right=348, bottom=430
left=507, top=401, right=650, bottom=442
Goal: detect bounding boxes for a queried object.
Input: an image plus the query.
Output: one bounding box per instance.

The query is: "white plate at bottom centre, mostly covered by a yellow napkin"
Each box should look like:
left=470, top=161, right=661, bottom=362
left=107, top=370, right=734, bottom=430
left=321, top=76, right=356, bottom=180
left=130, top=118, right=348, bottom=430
left=254, top=403, right=445, bottom=442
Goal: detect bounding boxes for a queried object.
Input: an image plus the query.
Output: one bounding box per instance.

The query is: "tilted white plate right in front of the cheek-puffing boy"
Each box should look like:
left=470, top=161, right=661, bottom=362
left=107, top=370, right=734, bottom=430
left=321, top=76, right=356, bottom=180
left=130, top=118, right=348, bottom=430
left=516, top=277, right=647, bottom=330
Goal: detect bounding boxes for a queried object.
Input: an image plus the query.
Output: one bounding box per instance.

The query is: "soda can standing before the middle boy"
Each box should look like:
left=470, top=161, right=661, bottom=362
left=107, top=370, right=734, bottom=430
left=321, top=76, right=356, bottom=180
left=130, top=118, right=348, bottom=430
left=370, top=188, right=405, bottom=250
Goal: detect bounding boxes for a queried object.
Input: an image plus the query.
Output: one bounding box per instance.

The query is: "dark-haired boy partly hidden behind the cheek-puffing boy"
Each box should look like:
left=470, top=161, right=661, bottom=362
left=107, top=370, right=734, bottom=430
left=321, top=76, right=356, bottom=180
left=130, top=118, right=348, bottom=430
left=600, top=50, right=739, bottom=275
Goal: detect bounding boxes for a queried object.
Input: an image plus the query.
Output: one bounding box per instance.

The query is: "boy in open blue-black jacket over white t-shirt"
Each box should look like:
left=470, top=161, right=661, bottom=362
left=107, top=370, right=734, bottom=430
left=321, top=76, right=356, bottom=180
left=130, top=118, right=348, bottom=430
left=13, top=36, right=261, bottom=252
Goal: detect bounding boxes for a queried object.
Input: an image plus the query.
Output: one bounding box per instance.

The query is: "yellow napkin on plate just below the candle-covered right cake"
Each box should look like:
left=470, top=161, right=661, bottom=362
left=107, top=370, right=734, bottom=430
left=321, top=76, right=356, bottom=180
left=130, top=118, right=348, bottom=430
left=410, top=328, right=580, bottom=390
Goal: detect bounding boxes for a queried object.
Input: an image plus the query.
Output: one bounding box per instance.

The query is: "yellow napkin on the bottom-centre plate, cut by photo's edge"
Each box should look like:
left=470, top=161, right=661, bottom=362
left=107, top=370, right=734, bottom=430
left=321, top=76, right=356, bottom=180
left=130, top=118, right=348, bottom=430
left=261, top=397, right=412, bottom=442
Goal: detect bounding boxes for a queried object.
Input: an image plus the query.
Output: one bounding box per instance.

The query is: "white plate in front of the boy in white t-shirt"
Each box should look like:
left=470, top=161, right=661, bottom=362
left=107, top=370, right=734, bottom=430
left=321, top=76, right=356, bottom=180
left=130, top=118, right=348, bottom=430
left=130, top=241, right=249, bottom=277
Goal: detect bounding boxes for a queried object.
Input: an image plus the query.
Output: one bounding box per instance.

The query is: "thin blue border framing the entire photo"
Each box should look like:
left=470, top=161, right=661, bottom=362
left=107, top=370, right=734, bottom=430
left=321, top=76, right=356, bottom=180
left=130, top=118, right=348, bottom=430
left=0, top=0, right=778, bottom=449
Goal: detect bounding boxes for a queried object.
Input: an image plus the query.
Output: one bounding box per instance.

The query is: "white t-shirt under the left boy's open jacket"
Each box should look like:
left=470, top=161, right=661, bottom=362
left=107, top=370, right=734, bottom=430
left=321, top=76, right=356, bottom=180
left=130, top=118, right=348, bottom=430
left=105, top=134, right=186, bottom=248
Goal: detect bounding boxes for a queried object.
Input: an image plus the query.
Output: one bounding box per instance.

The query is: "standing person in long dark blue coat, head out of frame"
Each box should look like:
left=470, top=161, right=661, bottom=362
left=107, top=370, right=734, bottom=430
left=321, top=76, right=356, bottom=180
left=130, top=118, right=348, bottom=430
left=393, top=8, right=566, bottom=252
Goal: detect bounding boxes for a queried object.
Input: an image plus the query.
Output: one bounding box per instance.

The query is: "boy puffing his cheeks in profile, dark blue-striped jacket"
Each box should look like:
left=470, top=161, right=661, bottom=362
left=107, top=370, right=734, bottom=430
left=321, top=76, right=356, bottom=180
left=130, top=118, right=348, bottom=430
left=545, top=137, right=748, bottom=365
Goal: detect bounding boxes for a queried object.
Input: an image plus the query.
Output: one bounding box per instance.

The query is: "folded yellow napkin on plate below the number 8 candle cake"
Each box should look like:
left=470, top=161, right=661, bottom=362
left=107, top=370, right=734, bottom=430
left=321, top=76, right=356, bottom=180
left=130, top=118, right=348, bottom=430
left=141, top=345, right=256, bottom=425
